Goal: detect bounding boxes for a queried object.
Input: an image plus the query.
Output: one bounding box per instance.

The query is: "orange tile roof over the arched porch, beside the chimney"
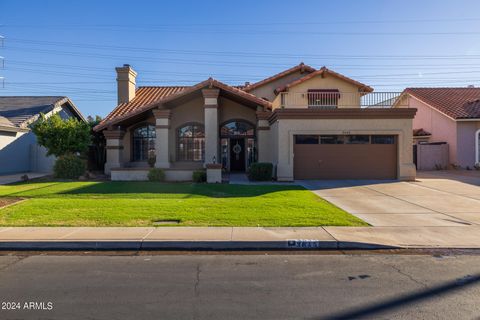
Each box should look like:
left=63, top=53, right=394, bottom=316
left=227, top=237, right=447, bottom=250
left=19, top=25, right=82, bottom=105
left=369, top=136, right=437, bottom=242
left=94, top=78, right=271, bottom=131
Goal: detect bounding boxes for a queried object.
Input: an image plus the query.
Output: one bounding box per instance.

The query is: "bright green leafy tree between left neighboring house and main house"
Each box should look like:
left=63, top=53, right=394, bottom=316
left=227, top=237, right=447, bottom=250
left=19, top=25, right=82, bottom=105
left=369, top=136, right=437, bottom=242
left=32, top=114, right=91, bottom=157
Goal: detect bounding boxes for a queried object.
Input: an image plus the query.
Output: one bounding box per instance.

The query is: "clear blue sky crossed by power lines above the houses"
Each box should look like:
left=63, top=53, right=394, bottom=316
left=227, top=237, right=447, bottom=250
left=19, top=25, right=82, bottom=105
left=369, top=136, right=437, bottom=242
left=0, top=0, right=480, bottom=116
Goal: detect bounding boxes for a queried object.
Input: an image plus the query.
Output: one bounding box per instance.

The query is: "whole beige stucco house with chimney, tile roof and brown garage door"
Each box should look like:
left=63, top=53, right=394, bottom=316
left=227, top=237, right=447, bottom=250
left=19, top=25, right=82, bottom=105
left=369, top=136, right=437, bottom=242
left=94, top=63, right=415, bottom=181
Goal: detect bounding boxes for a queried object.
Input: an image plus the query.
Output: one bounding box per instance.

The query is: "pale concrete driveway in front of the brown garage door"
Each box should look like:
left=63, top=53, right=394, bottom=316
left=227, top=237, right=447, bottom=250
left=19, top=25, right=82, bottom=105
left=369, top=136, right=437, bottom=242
left=300, top=171, right=480, bottom=227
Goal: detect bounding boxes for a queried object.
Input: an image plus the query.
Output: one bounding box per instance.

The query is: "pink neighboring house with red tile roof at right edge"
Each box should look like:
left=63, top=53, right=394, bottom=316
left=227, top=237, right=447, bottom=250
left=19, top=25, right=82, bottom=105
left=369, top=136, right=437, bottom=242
left=404, top=87, right=480, bottom=168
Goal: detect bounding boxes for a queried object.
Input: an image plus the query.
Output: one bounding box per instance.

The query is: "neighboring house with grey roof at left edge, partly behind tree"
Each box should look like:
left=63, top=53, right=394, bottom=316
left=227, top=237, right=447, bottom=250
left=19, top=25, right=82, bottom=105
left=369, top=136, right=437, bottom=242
left=0, top=96, right=85, bottom=174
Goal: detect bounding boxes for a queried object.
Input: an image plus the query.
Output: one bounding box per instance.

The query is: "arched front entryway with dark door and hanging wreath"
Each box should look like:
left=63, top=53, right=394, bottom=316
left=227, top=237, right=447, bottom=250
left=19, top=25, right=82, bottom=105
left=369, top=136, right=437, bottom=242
left=220, top=119, right=257, bottom=172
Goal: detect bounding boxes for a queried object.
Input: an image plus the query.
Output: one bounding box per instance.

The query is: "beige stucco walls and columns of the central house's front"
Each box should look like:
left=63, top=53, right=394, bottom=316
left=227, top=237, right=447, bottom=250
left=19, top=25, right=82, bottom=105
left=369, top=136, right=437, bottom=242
left=103, top=63, right=415, bottom=182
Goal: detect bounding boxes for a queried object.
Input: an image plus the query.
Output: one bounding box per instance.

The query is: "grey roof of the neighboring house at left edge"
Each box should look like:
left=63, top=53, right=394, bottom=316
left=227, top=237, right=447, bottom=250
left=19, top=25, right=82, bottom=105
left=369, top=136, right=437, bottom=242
left=0, top=96, right=85, bottom=128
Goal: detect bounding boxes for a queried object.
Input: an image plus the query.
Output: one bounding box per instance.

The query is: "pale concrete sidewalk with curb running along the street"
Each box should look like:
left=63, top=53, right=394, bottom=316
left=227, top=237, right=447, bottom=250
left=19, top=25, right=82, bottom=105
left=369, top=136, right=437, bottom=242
left=0, top=226, right=480, bottom=250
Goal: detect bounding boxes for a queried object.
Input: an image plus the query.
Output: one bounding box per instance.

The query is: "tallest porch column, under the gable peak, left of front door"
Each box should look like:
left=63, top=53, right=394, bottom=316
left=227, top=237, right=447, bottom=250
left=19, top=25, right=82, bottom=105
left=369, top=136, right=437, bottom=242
left=202, top=89, right=220, bottom=164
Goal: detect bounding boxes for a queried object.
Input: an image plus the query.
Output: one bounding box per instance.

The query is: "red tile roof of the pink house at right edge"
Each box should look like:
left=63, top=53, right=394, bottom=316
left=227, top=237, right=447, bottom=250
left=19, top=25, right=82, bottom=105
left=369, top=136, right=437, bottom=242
left=404, top=88, right=480, bottom=119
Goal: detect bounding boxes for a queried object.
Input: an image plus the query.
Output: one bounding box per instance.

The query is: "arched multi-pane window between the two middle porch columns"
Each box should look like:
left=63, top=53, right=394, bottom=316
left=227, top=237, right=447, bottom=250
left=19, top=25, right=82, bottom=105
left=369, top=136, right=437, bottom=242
left=177, top=123, right=205, bottom=161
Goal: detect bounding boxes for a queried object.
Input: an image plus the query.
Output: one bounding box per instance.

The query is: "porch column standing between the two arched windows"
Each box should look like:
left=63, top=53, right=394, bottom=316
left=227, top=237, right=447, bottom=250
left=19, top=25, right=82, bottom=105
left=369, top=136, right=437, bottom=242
left=153, top=109, right=171, bottom=168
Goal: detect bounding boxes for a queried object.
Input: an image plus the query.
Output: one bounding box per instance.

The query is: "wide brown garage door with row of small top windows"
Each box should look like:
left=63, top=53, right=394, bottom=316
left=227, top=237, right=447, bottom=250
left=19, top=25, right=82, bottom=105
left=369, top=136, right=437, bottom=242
left=294, top=144, right=397, bottom=179
